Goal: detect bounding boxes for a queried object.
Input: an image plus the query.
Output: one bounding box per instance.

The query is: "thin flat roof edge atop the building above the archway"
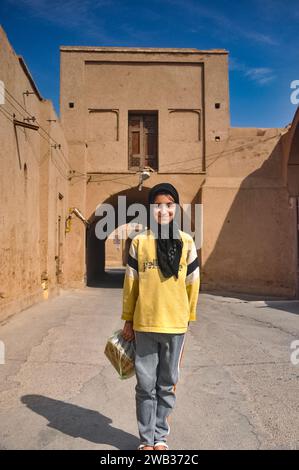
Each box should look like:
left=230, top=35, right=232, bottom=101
left=60, top=46, right=228, bottom=54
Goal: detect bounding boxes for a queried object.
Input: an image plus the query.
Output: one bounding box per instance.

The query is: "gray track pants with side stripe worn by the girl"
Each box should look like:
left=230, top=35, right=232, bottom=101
left=135, top=331, right=185, bottom=446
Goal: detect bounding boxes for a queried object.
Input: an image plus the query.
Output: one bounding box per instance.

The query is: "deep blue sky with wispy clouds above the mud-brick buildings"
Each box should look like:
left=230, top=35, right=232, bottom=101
left=0, top=0, right=299, bottom=127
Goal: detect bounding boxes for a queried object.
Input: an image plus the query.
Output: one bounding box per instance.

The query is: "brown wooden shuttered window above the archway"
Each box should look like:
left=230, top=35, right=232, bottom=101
left=128, top=111, right=158, bottom=170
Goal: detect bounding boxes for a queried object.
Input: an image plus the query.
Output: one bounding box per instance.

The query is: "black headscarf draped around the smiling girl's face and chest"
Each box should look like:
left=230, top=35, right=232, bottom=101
left=148, top=183, right=183, bottom=278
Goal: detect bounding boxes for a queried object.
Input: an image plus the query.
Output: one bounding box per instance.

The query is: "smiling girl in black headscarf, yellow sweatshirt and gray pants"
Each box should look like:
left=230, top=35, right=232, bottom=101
left=121, top=183, right=200, bottom=450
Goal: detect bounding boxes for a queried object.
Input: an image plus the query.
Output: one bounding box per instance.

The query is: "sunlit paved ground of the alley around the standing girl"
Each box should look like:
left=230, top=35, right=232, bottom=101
left=0, top=274, right=299, bottom=449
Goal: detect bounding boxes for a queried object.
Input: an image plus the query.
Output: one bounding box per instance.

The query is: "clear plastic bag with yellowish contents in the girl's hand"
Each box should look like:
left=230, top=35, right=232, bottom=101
left=104, top=330, right=136, bottom=379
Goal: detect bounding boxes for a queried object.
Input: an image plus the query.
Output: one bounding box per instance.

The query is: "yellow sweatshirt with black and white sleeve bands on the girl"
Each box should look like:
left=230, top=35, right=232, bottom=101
left=121, top=229, right=200, bottom=333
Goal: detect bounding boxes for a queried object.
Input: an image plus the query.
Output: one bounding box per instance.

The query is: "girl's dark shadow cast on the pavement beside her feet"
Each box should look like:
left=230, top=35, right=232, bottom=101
left=21, top=395, right=139, bottom=450
